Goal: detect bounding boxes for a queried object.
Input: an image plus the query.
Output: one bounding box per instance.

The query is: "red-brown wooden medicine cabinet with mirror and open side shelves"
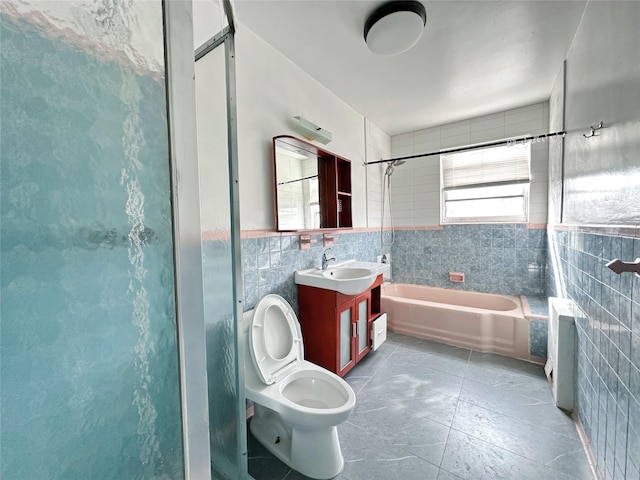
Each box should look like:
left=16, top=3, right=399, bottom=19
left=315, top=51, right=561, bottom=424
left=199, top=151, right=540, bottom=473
left=273, top=135, right=353, bottom=232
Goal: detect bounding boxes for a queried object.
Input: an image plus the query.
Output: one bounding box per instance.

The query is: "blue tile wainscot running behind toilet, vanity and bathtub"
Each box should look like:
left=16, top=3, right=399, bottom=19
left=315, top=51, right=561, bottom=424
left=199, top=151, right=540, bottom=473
left=242, top=224, right=547, bottom=358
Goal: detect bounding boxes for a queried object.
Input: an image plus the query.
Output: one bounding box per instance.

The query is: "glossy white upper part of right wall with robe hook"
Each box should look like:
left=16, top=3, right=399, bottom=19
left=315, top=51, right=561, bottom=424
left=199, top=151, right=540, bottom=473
left=562, top=2, right=640, bottom=225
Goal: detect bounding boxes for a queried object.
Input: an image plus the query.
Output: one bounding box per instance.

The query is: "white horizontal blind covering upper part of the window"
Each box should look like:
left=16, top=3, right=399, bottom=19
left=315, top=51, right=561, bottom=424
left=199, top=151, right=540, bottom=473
left=440, top=143, right=531, bottom=190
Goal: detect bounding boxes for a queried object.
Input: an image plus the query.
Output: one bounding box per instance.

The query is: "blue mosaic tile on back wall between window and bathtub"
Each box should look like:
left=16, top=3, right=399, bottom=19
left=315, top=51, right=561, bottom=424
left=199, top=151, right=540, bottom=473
left=391, top=224, right=547, bottom=297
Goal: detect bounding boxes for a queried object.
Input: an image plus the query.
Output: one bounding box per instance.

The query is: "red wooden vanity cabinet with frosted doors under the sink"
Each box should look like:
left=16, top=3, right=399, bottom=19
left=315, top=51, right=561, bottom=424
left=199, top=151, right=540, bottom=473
left=298, top=275, right=382, bottom=376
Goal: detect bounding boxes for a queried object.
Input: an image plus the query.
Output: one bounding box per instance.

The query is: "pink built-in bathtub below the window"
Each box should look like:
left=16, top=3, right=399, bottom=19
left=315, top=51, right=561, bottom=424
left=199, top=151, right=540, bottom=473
left=380, top=284, right=539, bottom=361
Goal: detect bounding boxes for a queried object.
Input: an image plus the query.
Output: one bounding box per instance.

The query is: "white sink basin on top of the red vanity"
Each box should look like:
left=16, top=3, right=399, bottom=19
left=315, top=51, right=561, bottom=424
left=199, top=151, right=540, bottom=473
left=295, top=260, right=388, bottom=295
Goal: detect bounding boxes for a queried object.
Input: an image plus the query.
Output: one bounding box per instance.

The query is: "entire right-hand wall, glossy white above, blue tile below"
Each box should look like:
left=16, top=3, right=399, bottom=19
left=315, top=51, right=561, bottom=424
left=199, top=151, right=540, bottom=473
left=548, top=2, right=640, bottom=480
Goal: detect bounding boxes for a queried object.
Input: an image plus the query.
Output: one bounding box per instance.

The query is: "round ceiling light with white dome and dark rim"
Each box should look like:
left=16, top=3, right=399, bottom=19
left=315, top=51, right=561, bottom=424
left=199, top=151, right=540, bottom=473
left=364, top=0, right=427, bottom=55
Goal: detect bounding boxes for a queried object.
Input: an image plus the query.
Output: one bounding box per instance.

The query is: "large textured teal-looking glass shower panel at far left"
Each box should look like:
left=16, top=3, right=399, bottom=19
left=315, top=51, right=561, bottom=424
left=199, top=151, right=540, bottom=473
left=0, top=2, right=183, bottom=480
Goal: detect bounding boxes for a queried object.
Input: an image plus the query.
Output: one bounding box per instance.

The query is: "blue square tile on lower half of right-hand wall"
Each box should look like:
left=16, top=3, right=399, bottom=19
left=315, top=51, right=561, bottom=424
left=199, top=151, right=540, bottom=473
left=548, top=230, right=640, bottom=479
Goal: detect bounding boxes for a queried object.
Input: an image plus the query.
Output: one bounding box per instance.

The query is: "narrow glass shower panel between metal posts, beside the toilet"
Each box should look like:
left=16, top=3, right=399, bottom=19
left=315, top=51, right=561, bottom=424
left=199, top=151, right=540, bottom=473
left=196, top=46, right=246, bottom=478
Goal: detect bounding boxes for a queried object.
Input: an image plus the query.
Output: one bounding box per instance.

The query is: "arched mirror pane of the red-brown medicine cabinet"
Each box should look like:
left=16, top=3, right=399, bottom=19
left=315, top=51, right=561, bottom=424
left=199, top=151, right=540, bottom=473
left=275, top=139, right=320, bottom=230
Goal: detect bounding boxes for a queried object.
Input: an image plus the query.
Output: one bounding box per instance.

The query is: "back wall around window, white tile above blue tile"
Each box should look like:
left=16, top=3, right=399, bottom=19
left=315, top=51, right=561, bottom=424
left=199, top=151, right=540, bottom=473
left=385, top=102, right=549, bottom=297
